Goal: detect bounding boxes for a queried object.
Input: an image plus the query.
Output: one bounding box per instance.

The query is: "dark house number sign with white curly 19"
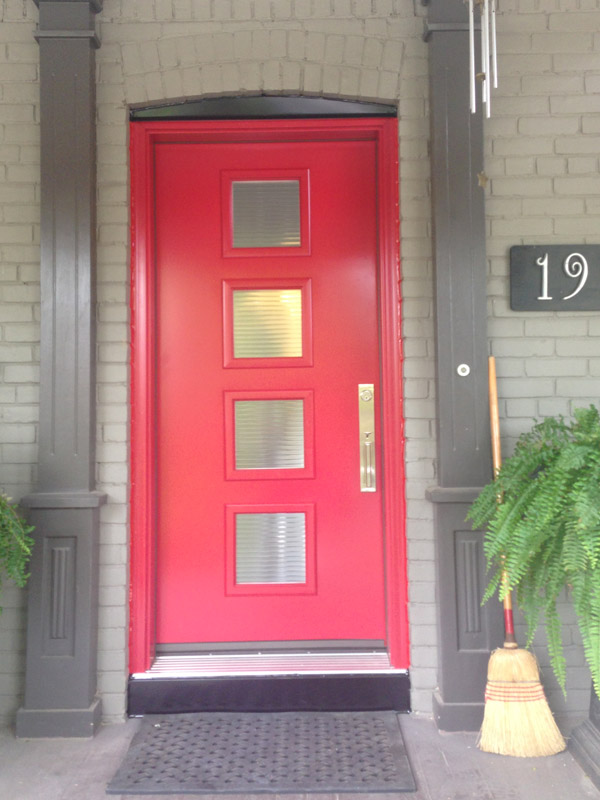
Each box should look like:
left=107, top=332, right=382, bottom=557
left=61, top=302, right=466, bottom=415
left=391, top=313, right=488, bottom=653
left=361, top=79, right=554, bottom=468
left=510, top=244, right=600, bottom=312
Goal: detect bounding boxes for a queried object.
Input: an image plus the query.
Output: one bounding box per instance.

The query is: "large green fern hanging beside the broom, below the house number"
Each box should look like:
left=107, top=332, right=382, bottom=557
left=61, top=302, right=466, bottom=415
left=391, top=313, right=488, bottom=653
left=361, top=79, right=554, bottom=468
left=467, top=406, right=600, bottom=693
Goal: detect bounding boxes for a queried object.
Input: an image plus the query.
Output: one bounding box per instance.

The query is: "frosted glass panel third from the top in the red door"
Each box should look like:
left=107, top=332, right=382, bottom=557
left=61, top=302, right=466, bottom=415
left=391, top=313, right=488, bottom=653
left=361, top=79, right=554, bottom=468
left=234, top=400, right=304, bottom=469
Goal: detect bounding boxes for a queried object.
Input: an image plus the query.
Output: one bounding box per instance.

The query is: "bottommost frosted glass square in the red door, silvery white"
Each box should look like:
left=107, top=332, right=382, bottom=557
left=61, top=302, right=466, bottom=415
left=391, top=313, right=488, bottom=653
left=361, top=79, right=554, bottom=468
left=235, top=513, right=306, bottom=583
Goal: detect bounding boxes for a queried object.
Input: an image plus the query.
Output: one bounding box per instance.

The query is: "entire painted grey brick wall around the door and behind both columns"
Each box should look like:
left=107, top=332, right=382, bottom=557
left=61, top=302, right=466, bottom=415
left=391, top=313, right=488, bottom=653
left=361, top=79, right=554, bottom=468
left=0, top=0, right=600, bottom=722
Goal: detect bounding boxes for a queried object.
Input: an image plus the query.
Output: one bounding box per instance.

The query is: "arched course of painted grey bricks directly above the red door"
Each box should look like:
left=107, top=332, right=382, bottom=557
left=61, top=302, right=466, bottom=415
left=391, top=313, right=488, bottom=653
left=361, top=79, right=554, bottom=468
left=120, top=36, right=404, bottom=106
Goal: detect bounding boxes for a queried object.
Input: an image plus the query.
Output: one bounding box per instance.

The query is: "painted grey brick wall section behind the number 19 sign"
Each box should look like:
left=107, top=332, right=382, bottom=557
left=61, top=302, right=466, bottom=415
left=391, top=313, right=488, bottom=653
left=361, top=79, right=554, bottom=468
left=485, top=0, right=600, bottom=714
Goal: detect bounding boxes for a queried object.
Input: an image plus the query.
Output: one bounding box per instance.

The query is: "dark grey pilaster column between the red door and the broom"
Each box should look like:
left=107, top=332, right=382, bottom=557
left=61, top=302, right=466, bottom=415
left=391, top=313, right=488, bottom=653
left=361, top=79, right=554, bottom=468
left=426, top=0, right=502, bottom=730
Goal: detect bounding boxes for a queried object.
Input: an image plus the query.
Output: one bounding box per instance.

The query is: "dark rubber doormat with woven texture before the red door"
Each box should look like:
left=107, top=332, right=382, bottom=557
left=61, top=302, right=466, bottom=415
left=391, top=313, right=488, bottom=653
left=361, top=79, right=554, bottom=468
left=107, top=711, right=416, bottom=794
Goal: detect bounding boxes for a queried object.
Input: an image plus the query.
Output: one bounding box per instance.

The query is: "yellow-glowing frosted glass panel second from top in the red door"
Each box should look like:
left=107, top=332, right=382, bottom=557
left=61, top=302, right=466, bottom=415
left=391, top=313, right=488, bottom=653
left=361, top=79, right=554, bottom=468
left=233, top=289, right=302, bottom=358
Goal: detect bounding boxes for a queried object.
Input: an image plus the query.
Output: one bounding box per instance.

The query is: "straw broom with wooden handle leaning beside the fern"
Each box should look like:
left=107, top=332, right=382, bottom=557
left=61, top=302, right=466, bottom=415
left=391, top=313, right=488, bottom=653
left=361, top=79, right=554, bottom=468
left=478, top=356, right=565, bottom=757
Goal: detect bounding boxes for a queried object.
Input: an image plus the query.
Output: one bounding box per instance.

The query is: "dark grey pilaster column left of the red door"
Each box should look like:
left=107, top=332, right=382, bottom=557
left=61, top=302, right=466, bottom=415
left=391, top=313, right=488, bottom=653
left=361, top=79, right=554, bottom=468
left=17, top=0, right=105, bottom=737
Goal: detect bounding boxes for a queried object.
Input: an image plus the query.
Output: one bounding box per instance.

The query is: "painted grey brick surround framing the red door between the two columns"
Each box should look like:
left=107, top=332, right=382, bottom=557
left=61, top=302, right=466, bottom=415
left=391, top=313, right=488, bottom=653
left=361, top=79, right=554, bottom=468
left=97, top=0, right=436, bottom=718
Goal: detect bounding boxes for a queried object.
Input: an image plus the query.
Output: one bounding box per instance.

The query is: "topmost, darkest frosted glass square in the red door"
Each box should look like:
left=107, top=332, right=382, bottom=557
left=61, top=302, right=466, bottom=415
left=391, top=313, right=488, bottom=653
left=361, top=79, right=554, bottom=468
left=232, top=181, right=300, bottom=247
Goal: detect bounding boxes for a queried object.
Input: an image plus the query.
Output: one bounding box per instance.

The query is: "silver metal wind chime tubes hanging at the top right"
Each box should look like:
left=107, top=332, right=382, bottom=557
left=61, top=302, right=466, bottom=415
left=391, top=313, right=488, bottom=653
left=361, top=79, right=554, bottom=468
left=468, top=0, right=498, bottom=118
